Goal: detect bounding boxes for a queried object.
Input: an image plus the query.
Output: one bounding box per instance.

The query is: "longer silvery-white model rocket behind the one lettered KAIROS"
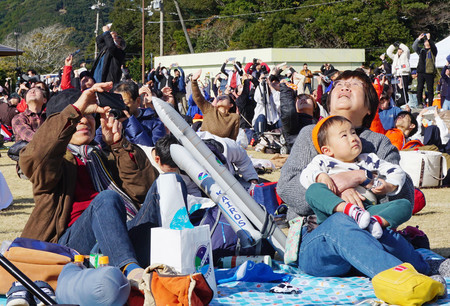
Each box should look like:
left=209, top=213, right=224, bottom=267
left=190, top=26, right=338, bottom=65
left=152, top=97, right=286, bottom=256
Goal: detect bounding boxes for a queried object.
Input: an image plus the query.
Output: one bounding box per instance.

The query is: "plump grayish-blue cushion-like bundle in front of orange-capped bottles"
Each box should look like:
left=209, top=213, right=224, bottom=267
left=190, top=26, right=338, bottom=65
left=56, top=262, right=130, bottom=306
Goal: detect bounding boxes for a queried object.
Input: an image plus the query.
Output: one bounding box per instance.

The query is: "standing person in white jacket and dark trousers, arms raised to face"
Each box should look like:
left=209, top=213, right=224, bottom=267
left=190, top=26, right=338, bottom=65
left=386, top=42, right=411, bottom=105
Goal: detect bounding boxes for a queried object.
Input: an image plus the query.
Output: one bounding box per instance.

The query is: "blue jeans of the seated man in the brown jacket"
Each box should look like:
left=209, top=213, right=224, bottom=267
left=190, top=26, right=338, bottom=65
left=58, top=175, right=187, bottom=268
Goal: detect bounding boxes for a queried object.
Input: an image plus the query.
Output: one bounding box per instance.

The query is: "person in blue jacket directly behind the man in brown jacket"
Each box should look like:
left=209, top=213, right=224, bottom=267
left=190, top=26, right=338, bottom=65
left=95, top=81, right=166, bottom=147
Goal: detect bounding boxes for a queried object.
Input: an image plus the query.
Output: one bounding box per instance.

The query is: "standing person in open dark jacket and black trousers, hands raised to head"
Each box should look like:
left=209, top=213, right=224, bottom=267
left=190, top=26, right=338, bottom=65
left=413, top=33, right=437, bottom=106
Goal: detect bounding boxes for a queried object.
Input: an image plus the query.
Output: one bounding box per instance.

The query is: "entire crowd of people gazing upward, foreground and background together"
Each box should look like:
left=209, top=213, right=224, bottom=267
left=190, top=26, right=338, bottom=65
left=0, top=26, right=450, bottom=304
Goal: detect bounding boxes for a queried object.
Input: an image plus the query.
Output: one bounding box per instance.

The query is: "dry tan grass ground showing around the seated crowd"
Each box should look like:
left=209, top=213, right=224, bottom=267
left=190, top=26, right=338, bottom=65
left=0, top=143, right=450, bottom=257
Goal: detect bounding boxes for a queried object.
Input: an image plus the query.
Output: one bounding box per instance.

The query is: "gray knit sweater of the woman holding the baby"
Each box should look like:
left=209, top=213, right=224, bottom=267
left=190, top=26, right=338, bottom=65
left=277, top=125, right=414, bottom=220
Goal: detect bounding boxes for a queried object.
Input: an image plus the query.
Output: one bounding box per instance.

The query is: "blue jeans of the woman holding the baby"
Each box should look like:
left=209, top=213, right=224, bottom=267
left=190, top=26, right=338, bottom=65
left=298, top=213, right=429, bottom=278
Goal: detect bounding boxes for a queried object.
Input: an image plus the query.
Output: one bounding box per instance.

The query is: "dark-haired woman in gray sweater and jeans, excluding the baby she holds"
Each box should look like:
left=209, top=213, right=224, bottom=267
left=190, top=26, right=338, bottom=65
left=277, top=71, right=448, bottom=290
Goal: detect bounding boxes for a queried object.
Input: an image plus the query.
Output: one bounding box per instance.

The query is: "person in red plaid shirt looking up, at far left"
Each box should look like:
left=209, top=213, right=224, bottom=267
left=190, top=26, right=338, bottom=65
left=11, top=87, right=47, bottom=142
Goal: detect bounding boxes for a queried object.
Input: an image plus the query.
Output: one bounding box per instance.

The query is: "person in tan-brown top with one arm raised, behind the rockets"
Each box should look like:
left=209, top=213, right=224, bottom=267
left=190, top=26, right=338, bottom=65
left=192, top=69, right=239, bottom=140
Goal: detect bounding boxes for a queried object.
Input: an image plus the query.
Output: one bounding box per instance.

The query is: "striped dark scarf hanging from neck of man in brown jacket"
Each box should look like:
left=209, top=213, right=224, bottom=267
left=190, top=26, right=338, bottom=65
left=67, top=144, right=139, bottom=220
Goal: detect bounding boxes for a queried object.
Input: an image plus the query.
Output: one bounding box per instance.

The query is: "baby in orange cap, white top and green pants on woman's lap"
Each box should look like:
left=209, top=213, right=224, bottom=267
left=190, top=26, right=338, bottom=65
left=300, top=116, right=412, bottom=239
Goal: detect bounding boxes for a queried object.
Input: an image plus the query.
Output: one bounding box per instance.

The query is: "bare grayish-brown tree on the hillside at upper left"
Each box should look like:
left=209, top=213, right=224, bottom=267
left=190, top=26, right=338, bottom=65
left=2, top=24, right=75, bottom=74
